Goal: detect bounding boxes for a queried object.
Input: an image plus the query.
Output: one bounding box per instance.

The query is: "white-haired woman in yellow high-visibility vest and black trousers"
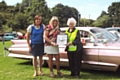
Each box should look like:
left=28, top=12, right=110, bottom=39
left=65, top=18, right=83, bottom=78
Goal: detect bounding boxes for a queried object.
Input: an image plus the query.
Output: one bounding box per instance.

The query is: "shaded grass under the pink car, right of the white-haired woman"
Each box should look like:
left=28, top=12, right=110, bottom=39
left=81, top=69, right=120, bottom=80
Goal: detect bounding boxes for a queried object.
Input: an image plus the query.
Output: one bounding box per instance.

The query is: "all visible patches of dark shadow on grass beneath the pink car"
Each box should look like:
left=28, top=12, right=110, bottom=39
left=15, top=60, right=120, bottom=80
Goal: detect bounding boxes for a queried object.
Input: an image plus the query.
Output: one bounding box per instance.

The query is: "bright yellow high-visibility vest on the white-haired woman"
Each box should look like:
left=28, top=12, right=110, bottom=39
left=65, top=28, right=78, bottom=51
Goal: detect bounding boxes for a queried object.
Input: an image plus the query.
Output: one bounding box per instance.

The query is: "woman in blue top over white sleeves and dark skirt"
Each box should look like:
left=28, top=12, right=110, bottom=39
left=27, top=15, right=44, bottom=77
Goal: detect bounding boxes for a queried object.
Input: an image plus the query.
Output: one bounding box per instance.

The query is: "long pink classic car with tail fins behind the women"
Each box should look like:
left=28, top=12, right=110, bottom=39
left=8, top=27, right=120, bottom=71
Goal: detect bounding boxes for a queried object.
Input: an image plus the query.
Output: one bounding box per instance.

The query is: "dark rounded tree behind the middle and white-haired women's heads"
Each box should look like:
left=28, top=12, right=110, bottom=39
left=52, top=4, right=78, bottom=27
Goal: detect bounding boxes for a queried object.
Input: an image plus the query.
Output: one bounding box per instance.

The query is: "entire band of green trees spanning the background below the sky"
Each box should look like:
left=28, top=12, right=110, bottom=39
left=0, top=0, right=120, bottom=31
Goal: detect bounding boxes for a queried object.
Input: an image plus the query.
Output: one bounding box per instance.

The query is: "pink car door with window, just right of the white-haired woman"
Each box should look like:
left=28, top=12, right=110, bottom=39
left=80, top=30, right=99, bottom=69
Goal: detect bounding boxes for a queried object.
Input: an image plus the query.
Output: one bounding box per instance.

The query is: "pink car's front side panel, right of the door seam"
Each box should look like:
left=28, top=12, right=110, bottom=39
left=99, top=46, right=120, bottom=71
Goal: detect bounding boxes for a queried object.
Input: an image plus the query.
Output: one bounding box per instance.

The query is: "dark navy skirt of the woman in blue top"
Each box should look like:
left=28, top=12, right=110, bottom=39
left=30, top=44, right=44, bottom=56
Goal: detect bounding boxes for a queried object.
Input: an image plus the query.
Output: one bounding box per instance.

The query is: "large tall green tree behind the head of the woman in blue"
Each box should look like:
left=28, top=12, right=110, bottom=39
left=7, top=0, right=50, bottom=30
